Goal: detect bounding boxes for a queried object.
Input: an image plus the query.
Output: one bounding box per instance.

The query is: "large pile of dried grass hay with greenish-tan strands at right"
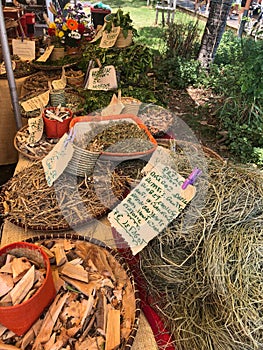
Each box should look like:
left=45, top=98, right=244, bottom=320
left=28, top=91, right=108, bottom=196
left=141, top=158, right=263, bottom=350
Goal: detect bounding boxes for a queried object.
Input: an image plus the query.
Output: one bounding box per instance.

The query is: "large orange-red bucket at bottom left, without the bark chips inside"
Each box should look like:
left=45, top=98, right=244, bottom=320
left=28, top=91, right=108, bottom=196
left=0, top=242, right=56, bottom=336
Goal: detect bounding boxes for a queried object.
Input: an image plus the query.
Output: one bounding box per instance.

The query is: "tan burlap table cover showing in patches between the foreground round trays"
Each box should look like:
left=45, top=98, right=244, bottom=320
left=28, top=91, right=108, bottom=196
left=1, top=155, right=158, bottom=350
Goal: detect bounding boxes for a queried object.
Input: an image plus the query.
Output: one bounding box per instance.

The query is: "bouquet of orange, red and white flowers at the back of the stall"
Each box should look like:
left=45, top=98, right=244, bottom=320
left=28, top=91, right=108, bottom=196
left=48, top=3, right=95, bottom=47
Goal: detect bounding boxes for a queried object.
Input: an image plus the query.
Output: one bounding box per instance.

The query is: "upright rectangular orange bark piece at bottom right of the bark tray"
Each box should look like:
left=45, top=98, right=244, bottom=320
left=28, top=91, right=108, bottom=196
left=105, top=309, right=121, bottom=350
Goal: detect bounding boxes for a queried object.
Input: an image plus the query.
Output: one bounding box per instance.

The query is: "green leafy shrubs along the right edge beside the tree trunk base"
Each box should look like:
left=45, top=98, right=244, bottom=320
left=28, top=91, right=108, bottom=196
left=197, top=31, right=263, bottom=165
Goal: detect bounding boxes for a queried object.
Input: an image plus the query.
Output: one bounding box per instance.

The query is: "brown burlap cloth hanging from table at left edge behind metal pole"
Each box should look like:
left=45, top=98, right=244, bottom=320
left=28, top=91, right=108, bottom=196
left=0, top=77, right=27, bottom=165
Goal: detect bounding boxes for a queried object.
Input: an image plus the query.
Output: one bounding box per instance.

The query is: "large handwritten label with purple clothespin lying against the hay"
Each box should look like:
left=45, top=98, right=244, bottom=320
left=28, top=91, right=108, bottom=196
left=108, top=146, right=195, bottom=255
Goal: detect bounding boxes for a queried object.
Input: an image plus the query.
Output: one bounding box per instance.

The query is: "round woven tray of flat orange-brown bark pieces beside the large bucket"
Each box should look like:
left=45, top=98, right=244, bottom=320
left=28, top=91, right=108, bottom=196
left=0, top=233, right=140, bottom=350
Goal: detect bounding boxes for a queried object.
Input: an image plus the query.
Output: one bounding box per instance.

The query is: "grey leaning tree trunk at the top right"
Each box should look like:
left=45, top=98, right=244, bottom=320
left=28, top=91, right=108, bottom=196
left=198, top=0, right=232, bottom=70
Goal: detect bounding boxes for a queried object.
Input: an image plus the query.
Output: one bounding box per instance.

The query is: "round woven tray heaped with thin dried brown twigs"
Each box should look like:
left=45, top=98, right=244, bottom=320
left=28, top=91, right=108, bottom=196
left=0, top=161, right=146, bottom=231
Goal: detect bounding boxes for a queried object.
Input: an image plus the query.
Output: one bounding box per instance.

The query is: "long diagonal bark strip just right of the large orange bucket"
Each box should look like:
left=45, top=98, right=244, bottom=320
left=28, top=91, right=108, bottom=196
left=32, top=293, right=69, bottom=350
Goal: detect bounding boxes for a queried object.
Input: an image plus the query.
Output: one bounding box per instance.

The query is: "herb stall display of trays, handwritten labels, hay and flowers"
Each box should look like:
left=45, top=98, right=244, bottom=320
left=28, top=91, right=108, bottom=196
left=0, top=1, right=263, bottom=350
